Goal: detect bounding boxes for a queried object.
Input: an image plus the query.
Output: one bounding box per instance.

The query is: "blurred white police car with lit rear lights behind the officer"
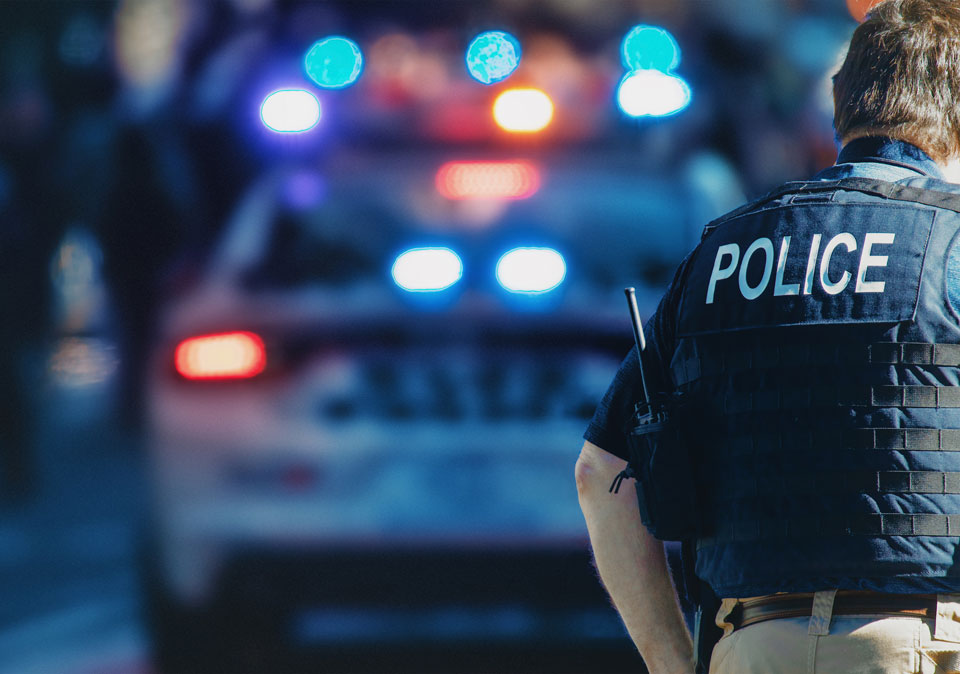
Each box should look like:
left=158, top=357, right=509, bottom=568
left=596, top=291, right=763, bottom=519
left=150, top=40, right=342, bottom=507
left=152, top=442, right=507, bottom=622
left=145, top=154, right=687, bottom=671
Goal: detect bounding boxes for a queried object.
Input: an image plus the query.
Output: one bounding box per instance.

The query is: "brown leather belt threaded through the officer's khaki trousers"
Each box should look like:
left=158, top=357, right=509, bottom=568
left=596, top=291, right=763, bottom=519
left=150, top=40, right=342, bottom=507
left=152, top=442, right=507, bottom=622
left=727, top=590, right=937, bottom=630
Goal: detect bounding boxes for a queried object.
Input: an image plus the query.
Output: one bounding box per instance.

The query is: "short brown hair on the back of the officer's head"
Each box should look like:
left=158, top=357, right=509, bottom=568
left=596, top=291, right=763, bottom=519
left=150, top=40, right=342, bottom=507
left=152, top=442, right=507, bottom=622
left=833, top=0, right=960, bottom=161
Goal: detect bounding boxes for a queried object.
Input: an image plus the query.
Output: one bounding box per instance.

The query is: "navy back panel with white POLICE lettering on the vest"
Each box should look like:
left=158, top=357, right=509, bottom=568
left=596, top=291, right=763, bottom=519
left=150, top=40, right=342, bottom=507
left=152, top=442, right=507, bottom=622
left=679, top=203, right=936, bottom=336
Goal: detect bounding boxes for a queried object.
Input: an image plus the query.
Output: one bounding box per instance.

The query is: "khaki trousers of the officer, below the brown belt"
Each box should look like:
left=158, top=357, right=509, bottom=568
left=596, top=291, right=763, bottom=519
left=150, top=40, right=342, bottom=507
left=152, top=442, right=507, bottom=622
left=710, top=590, right=960, bottom=674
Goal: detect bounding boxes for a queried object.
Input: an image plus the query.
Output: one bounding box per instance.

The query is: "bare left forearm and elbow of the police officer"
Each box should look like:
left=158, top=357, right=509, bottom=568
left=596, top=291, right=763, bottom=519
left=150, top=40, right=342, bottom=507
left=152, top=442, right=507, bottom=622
left=576, top=442, right=693, bottom=674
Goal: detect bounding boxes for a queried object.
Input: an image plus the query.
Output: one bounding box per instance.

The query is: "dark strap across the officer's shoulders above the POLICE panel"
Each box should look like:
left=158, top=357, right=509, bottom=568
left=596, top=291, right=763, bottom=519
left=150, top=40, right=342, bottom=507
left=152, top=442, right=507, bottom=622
left=703, top=178, right=960, bottom=237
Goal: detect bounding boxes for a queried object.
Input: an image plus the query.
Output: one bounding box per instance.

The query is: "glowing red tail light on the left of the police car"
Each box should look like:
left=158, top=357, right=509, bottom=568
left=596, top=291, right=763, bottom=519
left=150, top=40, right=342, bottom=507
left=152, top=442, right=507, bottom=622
left=174, top=332, right=267, bottom=379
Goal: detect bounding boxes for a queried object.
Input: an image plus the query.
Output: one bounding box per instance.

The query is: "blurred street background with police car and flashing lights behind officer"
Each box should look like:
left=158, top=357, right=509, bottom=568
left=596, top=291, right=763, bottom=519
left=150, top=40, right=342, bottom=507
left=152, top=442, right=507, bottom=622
left=0, top=0, right=870, bottom=674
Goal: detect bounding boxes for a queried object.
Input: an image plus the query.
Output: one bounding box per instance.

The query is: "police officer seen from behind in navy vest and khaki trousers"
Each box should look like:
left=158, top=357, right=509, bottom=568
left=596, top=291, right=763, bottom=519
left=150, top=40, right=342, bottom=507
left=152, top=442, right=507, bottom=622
left=576, top=0, right=960, bottom=674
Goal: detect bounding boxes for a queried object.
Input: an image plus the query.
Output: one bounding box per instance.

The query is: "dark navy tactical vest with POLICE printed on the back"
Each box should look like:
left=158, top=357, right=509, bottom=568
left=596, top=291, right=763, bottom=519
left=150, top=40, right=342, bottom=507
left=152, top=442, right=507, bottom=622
left=671, top=178, right=960, bottom=597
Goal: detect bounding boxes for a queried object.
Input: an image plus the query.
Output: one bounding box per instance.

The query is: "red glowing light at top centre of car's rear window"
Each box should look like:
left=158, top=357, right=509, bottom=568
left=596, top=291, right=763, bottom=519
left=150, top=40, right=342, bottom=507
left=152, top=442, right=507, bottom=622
left=436, top=161, right=540, bottom=199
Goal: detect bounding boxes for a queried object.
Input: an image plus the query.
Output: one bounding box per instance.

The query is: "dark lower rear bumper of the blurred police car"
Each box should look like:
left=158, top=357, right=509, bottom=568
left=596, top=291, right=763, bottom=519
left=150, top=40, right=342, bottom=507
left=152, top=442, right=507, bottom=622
left=204, top=546, right=628, bottom=648
